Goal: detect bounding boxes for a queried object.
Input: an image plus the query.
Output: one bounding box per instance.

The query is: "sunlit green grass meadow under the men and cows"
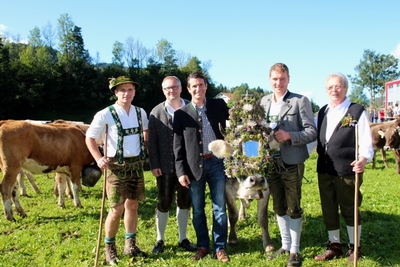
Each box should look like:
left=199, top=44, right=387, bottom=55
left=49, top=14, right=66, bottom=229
left=0, top=153, right=400, bottom=267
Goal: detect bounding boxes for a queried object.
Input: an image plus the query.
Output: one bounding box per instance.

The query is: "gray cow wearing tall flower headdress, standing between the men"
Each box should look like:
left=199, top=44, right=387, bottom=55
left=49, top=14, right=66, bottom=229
left=209, top=95, right=278, bottom=252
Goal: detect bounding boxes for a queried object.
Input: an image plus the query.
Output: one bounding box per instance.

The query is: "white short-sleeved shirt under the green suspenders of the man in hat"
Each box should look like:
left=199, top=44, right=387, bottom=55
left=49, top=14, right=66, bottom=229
left=86, top=104, right=148, bottom=157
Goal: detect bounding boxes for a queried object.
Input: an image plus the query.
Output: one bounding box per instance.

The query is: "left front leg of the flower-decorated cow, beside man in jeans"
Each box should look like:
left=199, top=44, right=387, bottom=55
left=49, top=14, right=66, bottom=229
left=225, top=178, right=239, bottom=245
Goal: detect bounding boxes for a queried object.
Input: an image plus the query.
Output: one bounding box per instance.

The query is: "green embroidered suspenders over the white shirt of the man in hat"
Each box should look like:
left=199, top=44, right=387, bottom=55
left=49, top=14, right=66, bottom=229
left=108, top=106, right=146, bottom=164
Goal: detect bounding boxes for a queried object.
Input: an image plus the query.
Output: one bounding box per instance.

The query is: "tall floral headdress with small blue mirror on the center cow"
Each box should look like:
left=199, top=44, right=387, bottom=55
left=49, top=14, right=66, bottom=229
left=209, top=94, right=273, bottom=178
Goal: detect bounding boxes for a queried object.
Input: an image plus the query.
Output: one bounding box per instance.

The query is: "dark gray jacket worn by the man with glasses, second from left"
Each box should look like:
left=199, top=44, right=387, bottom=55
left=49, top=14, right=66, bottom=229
left=148, top=99, right=189, bottom=175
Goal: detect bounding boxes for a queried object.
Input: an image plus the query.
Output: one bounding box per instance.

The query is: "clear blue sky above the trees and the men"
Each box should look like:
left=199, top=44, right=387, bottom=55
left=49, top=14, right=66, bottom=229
left=0, top=0, right=400, bottom=106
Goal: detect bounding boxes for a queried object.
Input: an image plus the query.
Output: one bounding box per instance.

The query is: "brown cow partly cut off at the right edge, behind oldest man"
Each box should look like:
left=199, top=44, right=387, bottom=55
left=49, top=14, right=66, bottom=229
left=370, top=119, right=400, bottom=174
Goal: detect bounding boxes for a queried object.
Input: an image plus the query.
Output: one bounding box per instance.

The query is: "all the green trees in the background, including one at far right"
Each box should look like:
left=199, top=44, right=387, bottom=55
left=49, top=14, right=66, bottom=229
left=0, top=14, right=399, bottom=122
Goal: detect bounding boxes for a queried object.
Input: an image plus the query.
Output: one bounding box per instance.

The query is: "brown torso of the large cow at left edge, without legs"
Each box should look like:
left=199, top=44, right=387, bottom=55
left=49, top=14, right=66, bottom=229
left=0, top=121, right=93, bottom=174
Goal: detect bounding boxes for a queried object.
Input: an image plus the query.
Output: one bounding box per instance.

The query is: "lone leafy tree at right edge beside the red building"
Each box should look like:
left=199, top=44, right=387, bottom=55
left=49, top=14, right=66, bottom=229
left=348, top=50, right=400, bottom=107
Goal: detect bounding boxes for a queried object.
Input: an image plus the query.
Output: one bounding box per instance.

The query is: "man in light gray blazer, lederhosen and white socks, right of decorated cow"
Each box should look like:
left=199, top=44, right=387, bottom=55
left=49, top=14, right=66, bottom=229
left=261, top=63, right=317, bottom=267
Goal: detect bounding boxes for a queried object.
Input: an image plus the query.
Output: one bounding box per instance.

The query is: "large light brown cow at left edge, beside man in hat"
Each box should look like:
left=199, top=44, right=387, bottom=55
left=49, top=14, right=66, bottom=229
left=0, top=120, right=94, bottom=220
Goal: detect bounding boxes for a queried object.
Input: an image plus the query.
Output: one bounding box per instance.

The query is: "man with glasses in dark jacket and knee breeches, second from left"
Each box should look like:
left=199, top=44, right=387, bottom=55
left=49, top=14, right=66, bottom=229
left=148, top=76, right=197, bottom=253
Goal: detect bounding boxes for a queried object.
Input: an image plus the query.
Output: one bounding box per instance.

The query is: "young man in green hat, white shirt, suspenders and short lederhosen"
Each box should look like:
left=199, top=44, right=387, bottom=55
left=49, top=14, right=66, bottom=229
left=86, top=76, right=148, bottom=265
